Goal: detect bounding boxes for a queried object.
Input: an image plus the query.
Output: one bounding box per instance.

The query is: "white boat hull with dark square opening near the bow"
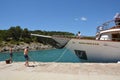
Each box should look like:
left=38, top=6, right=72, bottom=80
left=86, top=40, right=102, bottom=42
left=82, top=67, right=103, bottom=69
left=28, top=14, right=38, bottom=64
left=65, top=39, right=120, bottom=62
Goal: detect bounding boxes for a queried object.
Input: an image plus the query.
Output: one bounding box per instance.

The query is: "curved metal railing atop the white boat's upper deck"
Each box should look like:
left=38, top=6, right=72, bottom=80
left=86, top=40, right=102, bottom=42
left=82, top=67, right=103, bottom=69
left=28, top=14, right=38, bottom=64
left=97, top=20, right=120, bottom=33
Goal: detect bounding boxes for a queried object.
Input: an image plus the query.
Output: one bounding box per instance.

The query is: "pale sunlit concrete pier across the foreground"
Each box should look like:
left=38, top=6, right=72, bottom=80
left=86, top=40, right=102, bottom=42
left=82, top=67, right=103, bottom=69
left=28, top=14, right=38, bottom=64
left=0, top=62, right=120, bottom=80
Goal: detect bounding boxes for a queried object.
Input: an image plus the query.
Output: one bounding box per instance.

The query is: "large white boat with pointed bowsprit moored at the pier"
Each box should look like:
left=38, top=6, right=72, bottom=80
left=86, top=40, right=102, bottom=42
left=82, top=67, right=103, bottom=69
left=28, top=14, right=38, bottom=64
left=32, top=20, right=120, bottom=62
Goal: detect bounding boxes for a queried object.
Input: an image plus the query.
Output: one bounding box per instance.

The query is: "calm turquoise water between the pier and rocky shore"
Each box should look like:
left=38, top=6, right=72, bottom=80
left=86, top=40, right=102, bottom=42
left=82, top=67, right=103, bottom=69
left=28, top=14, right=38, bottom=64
left=0, top=48, right=80, bottom=62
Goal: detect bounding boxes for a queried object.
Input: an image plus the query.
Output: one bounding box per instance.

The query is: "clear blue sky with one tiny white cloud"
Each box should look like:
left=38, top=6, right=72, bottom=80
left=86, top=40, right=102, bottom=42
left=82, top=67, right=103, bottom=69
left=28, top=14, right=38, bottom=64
left=0, top=0, right=120, bottom=36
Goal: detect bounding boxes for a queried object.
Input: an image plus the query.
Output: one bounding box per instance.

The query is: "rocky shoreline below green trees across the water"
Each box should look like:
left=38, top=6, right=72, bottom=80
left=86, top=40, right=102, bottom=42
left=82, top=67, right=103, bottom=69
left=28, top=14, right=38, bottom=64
left=0, top=42, right=53, bottom=52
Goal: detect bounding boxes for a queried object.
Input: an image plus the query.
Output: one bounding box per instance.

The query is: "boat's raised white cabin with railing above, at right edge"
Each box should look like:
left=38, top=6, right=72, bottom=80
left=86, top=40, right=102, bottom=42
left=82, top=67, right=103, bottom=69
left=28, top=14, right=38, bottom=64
left=96, top=20, right=120, bottom=41
